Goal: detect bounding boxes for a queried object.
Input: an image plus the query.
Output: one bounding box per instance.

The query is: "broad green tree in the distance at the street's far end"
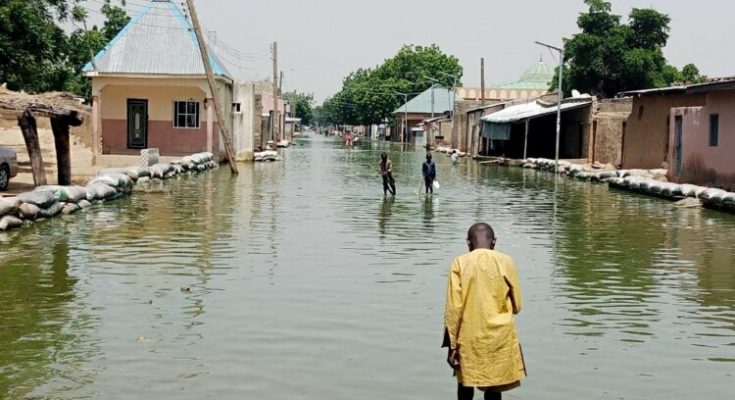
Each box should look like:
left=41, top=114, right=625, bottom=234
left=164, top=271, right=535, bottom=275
left=317, top=45, right=462, bottom=125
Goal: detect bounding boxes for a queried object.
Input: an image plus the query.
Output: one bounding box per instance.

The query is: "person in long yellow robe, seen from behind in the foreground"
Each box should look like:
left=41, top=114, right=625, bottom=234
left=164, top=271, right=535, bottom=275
left=442, top=223, right=526, bottom=400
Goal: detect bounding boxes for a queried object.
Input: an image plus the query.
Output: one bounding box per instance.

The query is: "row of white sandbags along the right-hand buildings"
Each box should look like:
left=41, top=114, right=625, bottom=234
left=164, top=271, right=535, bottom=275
left=520, top=158, right=735, bottom=213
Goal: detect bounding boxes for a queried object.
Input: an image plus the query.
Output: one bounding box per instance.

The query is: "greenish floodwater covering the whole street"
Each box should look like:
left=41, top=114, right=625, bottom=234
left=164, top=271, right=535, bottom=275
left=0, top=136, right=735, bottom=400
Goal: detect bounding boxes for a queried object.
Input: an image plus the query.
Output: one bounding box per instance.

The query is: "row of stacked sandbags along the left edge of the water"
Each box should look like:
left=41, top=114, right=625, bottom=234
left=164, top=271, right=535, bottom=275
left=0, top=153, right=218, bottom=231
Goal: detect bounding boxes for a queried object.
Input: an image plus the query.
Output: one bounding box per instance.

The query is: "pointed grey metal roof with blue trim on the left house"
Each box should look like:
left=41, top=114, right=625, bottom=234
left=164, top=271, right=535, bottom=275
left=82, top=1, right=232, bottom=78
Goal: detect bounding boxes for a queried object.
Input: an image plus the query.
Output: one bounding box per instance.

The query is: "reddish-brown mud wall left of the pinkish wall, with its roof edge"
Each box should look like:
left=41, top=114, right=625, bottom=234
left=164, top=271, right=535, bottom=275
left=622, top=93, right=705, bottom=169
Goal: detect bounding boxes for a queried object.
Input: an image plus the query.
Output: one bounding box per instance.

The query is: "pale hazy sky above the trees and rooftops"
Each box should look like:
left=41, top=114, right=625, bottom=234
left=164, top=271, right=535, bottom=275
left=91, top=0, right=735, bottom=102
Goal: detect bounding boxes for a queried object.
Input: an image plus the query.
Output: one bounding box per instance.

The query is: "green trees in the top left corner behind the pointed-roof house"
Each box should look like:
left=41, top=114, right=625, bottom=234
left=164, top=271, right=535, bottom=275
left=0, top=0, right=128, bottom=95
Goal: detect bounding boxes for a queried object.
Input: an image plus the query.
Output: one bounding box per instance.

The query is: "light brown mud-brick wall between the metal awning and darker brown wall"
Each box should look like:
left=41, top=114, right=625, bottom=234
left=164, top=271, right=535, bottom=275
left=587, top=98, right=633, bottom=167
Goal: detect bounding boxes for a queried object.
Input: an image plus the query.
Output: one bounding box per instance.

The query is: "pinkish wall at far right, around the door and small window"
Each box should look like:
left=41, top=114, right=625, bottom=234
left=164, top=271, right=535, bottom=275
left=668, top=91, right=735, bottom=190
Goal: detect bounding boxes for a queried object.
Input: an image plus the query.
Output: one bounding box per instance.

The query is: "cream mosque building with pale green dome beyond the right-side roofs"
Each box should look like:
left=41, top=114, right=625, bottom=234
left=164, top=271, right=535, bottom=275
left=457, top=59, right=554, bottom=101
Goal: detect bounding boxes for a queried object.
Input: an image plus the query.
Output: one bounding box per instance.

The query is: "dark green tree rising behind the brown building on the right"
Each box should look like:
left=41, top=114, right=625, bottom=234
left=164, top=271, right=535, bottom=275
left=552, top=0, right=701, bottom=98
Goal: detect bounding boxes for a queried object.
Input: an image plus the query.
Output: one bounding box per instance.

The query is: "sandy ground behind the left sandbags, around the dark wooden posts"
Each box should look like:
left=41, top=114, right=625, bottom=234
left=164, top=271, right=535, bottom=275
left=0, top=127, right=173, bottom=196
